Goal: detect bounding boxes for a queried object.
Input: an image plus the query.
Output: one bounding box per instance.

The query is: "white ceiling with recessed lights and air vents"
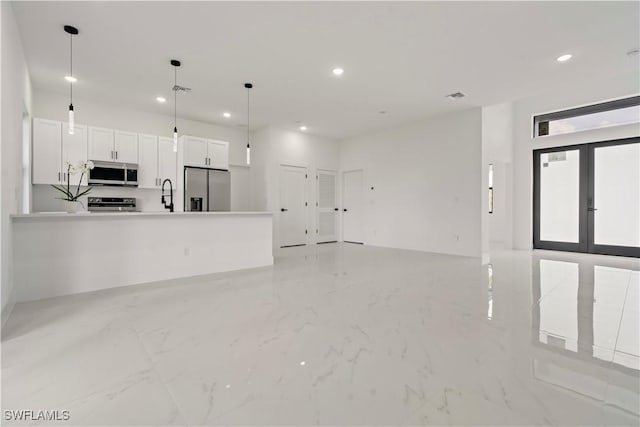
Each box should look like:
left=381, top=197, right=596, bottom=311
left=13, top=1, right=640, bottom=138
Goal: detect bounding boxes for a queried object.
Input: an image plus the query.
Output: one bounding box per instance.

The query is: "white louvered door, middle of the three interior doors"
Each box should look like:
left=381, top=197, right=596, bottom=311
left=316, top=170, right=338, bottom=243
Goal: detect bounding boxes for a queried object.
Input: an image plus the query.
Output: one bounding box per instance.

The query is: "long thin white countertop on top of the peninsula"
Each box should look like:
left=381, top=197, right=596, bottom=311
left=11, top=212, right=272, bottom=220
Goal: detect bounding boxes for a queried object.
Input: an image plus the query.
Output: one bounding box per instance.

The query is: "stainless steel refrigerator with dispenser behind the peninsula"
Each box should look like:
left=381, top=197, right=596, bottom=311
left=184, top=166, right=231, bottom=212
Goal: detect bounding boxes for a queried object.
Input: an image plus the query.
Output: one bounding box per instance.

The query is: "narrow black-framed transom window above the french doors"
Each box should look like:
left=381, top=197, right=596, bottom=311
left=533, top=96, right=640, bottom=137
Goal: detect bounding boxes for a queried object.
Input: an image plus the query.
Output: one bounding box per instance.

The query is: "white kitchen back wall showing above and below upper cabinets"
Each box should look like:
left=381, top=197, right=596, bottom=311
left=32, top=91, right=247, bottom=212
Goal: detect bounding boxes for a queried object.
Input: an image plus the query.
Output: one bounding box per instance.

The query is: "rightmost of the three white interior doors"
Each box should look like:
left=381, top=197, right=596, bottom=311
left=342, top=170, right=364, bottom=243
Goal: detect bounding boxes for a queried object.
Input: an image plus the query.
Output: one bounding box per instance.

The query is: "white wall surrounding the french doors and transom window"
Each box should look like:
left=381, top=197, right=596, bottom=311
left=513, top=73, right=640, bottom=249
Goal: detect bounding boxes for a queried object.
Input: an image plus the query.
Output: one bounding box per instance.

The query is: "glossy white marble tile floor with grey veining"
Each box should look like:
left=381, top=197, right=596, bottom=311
left=1, top=244, right=640, bottom=426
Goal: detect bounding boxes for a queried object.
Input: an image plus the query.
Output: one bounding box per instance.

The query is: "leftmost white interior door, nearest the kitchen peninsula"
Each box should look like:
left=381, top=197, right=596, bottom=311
left=279, top=166, right=307, bottom=247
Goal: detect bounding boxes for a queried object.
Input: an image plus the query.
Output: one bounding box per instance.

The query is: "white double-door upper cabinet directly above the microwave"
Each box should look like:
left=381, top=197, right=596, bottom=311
left=89, top=127, right=138, bottom=163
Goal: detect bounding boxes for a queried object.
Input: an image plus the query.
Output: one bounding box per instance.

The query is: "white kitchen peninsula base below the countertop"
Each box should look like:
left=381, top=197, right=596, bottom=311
left=12, top=212, right=273, bottom=302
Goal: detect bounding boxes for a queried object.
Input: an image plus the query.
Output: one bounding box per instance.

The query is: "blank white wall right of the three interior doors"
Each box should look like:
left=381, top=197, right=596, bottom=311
left=341, top=108, right=482, bottom=257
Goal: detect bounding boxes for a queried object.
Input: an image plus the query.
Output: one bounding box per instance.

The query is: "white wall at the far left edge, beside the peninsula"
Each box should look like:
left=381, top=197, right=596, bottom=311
left=0, top=2, right=31, bottom=323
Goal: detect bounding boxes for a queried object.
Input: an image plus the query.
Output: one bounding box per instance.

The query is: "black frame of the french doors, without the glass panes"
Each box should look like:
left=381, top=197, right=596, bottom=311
left=533, top=137, right=640, bottom=258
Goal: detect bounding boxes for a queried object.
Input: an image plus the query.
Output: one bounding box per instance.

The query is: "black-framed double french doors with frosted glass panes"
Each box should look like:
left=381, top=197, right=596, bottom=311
left=533, top=138, right=640, bottom=257
